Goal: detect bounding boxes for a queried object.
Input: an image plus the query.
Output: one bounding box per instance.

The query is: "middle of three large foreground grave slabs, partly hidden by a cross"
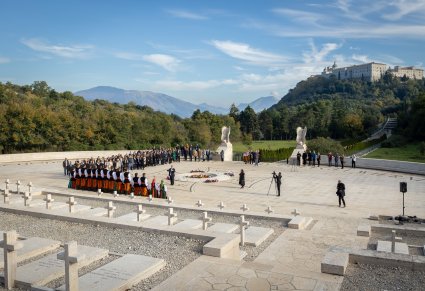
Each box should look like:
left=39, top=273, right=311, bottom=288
left=16, top=245, right=108, bottom=289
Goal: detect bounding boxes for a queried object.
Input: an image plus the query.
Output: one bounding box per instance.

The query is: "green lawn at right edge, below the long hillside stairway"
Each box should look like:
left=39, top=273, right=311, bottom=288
left=365, top=143, right=425, bottom=163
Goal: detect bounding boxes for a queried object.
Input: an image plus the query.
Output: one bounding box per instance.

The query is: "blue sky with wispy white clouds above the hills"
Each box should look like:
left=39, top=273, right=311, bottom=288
left=0, top=0, right=425, bottom=107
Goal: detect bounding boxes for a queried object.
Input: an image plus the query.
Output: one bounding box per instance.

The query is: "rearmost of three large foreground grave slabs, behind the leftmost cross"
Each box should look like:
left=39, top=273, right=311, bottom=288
left=0, top=237, right=60, bottom=269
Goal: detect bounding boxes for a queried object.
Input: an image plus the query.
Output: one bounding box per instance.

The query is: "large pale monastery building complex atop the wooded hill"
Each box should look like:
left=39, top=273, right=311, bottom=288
left=321, top=62, right=424, bottom=82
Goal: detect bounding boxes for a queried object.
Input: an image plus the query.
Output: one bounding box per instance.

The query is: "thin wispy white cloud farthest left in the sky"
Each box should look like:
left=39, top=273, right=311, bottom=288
left=21, top=38, right=94, bottom=59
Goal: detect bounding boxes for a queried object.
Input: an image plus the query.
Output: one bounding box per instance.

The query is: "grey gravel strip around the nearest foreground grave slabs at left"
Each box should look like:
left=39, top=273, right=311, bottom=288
left=0, top=212, right=205, bottom=290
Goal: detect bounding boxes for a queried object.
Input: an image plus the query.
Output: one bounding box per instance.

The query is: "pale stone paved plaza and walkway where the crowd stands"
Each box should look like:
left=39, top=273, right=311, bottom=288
left=0, top=159, right=425, bottom=290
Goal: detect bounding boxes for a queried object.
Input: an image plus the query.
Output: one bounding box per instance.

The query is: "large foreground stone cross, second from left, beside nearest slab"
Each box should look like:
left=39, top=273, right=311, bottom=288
left=57, top=241, right=85, bottom=291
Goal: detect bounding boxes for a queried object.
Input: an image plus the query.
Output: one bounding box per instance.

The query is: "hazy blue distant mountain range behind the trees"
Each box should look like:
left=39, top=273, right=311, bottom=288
left=75, top=86, right=279, bottom=118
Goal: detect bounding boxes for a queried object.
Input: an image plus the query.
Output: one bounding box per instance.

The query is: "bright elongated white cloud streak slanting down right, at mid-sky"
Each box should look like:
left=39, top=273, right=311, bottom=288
left=211, top=40, right=287, bottom=66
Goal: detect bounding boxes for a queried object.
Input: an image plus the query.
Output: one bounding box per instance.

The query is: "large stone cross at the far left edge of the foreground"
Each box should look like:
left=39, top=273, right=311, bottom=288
left=0, top=230, right=22, bottom=290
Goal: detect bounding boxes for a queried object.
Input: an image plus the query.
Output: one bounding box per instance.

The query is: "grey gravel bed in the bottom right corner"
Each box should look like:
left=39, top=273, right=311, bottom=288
left=340, top=264, right=425, bottom=291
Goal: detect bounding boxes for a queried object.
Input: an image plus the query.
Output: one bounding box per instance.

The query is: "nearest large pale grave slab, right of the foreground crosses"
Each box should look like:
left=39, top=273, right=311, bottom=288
left=59, top=254, right=165, bottom=291
